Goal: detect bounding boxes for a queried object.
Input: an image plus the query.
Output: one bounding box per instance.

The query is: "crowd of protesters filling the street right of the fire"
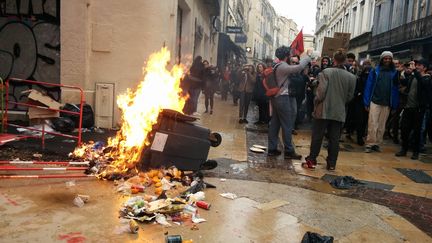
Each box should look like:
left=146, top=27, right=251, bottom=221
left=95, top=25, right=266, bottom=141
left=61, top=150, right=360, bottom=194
left=182, top=46, right=432, bottom=170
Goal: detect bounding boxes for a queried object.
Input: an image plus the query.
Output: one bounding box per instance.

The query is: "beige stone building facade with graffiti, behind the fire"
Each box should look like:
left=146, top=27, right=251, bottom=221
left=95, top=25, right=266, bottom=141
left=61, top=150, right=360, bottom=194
left=0, top=0, right=220, bottom=127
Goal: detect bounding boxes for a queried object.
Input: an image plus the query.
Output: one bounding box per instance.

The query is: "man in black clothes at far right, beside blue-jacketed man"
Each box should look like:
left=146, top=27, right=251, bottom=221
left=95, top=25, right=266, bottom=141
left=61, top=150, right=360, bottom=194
left=396, top=59, right=432, bottom=160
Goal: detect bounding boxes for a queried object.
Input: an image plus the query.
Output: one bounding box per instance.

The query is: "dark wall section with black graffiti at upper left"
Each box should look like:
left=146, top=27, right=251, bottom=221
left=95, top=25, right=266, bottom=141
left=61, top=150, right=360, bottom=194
left=0, top=0, right=60, bottom=109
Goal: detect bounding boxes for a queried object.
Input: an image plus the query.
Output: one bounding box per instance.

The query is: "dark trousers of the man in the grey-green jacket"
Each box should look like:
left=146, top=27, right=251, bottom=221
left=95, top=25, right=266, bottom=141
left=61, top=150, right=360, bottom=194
left=309, top=119, right=343, bottom=167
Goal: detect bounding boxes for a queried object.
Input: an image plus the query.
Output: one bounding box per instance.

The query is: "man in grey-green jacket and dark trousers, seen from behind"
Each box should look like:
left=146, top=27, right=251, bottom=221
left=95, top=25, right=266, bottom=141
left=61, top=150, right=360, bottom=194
left=302, top=50, right=357, bottom=170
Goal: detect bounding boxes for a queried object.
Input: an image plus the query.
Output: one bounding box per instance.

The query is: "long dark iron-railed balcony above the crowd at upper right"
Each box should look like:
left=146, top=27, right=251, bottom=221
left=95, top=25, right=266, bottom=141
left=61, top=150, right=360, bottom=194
left=369, top=15, right=432, bottom=52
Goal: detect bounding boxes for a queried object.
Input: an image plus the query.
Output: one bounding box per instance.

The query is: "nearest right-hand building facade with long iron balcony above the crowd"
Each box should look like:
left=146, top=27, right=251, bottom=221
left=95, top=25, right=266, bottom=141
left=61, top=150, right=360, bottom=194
left=368, top=0, right=432, bottom=61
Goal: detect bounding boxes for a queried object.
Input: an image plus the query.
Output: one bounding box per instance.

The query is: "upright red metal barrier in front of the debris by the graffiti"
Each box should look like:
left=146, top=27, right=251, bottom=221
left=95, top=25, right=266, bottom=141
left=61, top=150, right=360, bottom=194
left=3, top=78, right=85, bottom=147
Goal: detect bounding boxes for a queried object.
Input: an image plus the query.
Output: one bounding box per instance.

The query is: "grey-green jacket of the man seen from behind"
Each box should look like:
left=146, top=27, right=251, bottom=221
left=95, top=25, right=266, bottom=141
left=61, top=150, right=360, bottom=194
left=313, top=67, right=357, bottom=122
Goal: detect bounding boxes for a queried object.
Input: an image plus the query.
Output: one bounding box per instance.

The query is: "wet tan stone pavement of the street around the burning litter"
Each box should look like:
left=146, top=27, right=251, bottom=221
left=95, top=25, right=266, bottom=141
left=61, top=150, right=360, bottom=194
left=0, top=93, right=432, bottom=242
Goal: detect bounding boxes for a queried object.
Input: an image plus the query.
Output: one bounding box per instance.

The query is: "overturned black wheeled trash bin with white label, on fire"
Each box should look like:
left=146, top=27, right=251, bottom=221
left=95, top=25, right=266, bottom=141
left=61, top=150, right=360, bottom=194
left=139, top=110, right=222, bottom=171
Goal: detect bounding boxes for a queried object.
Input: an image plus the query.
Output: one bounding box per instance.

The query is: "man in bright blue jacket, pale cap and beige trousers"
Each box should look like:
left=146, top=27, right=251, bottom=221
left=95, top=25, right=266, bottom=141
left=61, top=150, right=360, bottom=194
left=363, top=51, right=399, bottom=153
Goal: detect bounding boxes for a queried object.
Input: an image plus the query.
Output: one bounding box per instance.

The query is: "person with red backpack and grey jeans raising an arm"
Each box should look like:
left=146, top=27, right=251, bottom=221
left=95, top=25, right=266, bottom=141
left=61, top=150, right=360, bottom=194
left=265, top=46, right=312, bottom=159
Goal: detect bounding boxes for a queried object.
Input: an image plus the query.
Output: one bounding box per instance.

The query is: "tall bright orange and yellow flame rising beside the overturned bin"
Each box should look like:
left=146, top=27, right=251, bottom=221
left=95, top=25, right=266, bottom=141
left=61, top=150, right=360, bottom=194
left=98, top=48, right=186, bottom=176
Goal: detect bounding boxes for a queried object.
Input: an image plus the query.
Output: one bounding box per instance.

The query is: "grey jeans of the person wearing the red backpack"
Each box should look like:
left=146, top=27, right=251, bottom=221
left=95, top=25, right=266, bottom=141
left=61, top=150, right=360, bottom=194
left=268, top=95, right=297, bottom=153
